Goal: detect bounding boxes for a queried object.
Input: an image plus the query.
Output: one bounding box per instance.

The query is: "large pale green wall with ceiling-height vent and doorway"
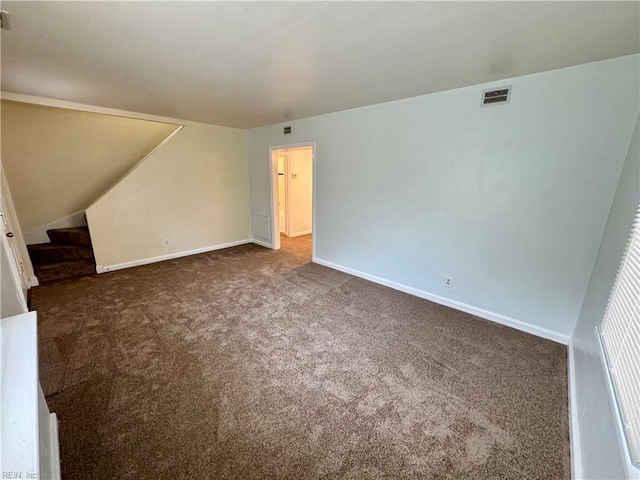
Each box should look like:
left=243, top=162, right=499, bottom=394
left=248, top=55, right=640, bottom=339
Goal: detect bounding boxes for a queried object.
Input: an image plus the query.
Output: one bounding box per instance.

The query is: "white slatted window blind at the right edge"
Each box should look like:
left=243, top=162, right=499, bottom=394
left=600, top=207, right=640, bottom=467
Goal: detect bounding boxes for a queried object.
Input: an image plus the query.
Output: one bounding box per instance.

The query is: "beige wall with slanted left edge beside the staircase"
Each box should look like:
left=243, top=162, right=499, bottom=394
left=87, top=122, right=251, bottom=270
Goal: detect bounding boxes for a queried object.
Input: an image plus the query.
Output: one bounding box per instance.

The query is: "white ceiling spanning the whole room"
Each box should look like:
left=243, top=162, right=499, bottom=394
left=2, top=1, right=640, bottom=128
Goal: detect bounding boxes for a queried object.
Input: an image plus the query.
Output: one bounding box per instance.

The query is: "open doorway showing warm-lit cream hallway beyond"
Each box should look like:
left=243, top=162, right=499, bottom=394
left=269, top=144, right=315, bottom=250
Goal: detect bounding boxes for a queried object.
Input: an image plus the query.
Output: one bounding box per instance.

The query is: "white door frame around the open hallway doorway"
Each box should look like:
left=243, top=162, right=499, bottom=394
left=269, top=142, right=316, bottom=253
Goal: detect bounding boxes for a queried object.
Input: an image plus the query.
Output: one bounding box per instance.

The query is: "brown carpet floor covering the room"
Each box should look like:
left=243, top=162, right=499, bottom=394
left=32, top=237, right=570, bottom=480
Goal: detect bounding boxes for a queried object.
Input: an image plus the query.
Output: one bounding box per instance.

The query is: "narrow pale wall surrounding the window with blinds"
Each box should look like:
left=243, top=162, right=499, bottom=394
left=572, top=114, right=640, bottom=479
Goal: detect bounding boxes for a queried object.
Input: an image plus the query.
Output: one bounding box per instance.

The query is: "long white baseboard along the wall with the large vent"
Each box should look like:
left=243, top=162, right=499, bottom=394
left=312, top=256, right=570, bottom=345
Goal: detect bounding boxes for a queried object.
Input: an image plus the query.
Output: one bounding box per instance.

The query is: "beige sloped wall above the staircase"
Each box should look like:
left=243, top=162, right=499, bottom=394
left=2, top=100, right=177, bottom=234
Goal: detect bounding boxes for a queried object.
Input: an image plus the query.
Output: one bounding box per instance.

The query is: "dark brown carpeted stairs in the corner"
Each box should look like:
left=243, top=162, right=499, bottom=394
left=27, top=227, right=96, bottom=284
